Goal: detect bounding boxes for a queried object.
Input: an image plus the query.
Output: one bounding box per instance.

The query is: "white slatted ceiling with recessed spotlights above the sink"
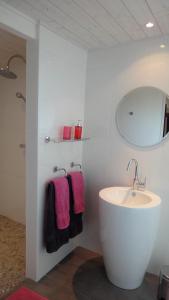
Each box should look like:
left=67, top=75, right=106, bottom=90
left=3, top=0, right=169, bottom=49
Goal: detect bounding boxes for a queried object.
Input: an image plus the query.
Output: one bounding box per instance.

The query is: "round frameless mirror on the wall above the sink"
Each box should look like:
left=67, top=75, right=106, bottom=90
left=116, top=86, right=169, bottom=147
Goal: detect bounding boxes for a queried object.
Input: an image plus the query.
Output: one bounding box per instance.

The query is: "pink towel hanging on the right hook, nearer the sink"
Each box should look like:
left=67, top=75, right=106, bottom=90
left=69, top=172, right=85, bottom=214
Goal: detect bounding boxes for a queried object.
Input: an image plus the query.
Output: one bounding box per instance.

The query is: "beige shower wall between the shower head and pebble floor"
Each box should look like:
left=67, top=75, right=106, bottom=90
left=0, top=59, right=26, bottom=224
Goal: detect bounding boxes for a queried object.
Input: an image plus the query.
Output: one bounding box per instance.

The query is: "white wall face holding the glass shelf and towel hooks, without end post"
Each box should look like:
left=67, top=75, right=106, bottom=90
left=36, top=26, right=87, bottom=279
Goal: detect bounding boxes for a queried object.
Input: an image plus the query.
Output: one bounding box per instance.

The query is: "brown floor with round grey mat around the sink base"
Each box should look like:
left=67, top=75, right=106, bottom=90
left=2, top=248, right=158, bottom=300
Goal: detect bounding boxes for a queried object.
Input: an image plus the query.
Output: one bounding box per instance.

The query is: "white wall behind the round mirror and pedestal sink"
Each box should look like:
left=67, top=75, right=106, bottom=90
left=82, top=38, right=169, bottom=272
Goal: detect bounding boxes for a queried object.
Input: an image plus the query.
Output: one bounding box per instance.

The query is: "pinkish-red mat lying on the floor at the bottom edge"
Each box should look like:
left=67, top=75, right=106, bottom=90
left=7, top=287, right=47, bottom=300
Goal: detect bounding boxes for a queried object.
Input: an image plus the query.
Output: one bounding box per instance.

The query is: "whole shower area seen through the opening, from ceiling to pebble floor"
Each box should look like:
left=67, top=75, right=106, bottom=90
left=0, top=29, right=26, bottom=298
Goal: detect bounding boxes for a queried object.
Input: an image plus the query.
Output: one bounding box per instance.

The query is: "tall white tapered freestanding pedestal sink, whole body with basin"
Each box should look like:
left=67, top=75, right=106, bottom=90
left=99, top=187, right=161, bottom=289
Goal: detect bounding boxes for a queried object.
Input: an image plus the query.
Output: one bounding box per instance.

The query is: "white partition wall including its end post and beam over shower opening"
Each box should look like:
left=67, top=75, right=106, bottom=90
left=0, top=4, right=87, bottom=280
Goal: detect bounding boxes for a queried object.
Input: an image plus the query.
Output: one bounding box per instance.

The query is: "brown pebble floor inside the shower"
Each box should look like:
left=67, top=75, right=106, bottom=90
left=0, top=215, right=25, bottom=298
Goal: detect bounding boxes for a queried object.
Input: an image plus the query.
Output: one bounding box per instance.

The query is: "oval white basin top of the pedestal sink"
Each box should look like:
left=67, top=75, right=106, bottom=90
left=99, top=187, right=161, bottom=208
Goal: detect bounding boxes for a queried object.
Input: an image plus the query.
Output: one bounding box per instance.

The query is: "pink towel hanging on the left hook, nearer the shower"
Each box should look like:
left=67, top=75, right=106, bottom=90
left=52, top=177, right=70, bottom=229
